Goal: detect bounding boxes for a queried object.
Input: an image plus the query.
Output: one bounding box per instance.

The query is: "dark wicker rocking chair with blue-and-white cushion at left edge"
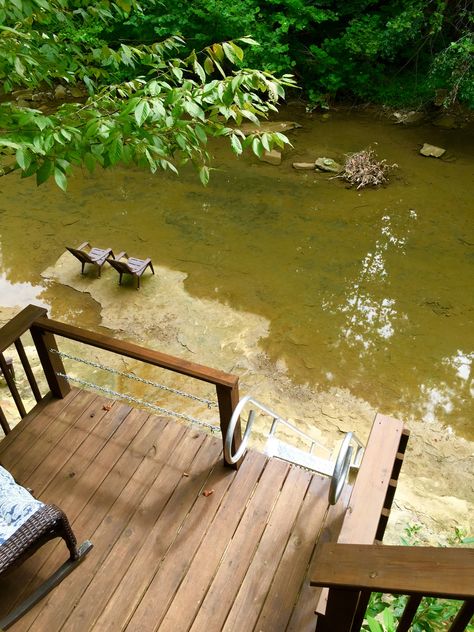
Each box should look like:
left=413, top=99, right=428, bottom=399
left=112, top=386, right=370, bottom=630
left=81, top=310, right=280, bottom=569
left=0, top=468, right=92, bottom=630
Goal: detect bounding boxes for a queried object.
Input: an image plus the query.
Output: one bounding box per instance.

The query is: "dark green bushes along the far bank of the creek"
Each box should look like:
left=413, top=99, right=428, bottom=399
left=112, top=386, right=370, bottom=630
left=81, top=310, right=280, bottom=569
left=109, top=0, right=474, bottom=106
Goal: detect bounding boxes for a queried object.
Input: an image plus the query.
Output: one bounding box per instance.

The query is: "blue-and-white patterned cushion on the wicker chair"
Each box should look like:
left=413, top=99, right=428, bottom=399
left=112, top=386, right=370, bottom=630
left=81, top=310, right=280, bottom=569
left=0, top=465, right=44, bottom=546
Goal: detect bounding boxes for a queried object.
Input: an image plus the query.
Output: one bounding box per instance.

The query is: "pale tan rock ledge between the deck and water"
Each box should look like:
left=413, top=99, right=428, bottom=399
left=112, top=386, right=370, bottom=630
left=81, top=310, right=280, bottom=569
left=0, top=254, right=474, bottom=543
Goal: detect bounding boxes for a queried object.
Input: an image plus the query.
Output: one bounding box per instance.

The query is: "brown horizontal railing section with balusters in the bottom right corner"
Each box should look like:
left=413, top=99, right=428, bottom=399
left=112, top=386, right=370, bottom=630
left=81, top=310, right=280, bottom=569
left=311, top=543, right=474, bottom=632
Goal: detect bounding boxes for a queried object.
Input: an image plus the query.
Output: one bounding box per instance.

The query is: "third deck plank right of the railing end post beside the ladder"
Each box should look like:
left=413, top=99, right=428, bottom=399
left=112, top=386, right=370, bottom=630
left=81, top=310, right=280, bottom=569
left=222, top=467, right=311, bottom=632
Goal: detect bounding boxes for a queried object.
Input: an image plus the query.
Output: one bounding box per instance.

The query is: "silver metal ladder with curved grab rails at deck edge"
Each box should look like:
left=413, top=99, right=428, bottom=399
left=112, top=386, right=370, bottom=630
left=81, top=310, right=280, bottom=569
left=224, top=395, right=364, bottom=505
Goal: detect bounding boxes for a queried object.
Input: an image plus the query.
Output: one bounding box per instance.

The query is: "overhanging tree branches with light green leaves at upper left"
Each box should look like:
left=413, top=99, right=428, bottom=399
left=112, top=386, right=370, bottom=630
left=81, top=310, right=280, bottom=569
left=0, top=0, right=293, bottom=189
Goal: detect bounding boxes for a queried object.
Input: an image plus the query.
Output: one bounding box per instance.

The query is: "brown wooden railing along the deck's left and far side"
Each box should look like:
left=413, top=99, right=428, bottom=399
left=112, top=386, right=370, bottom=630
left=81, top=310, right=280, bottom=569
left=0, top=305, right=241, bottom=467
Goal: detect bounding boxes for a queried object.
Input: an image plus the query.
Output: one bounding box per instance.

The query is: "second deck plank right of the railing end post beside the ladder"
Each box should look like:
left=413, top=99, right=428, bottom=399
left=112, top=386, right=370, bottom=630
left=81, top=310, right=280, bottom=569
left=191, top=460, right=289, bottom=632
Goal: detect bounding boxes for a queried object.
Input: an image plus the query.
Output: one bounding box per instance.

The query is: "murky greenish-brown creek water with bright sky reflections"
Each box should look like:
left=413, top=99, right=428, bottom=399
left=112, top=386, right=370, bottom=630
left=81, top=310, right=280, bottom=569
left=0, top=105, right=474, bottom=438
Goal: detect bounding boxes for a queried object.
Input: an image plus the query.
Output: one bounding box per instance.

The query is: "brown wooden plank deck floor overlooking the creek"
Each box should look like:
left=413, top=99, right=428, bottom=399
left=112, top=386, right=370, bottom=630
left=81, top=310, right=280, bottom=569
left=0, top=389, right=348, bottom=632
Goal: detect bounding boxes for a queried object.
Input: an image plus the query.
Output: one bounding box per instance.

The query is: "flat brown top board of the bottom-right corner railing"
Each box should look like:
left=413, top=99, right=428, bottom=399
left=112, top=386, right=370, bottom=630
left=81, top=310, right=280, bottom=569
left=311, top=543, right=474, bottom=599
